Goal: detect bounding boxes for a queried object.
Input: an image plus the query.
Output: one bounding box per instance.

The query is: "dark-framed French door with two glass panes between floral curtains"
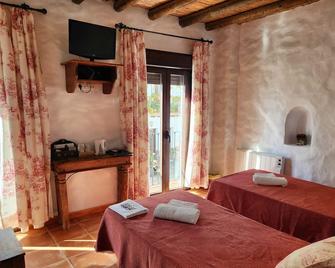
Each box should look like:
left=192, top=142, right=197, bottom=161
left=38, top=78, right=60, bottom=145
left=147, top=67, right=191, bottom=194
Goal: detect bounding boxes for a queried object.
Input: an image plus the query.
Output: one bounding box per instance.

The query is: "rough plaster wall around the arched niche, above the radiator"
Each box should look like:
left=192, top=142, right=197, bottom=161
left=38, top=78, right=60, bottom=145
left=212, top=0, right=335, bottom=187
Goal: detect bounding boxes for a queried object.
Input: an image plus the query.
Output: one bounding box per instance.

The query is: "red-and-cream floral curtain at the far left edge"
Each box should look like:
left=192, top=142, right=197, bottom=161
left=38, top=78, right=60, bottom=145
left=0, top=6, right=53, bottom=231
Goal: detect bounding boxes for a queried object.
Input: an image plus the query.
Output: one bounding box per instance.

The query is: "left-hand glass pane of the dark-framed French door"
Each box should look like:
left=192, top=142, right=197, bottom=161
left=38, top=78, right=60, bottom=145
left=147, top=73, right=163, bottom=194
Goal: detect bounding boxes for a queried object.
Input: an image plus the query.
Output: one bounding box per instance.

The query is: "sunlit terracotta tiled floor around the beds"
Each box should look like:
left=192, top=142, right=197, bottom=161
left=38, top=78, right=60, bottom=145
left=16, top=189, right=207, bottom=268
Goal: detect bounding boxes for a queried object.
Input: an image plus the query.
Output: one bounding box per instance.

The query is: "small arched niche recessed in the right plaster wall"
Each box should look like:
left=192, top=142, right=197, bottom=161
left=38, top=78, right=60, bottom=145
left=284, top=107, right=312, bottom=146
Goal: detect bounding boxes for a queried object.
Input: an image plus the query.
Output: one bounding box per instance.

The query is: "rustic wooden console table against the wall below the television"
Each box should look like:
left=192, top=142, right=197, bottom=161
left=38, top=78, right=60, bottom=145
left=52, top=155, right=132, bottom=229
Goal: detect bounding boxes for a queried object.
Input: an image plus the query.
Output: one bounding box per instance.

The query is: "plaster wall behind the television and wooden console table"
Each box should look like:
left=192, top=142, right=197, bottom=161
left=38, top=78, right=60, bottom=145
left=11, top=0, right=215, bottom=211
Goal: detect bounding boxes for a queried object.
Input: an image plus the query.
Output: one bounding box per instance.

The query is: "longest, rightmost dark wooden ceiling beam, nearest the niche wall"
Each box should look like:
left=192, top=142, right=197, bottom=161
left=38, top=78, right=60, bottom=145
left=206, top=0, right=320, bottom=31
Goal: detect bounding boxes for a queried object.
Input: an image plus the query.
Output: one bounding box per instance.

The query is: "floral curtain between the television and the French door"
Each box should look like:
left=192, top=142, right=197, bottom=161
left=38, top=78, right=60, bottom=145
left=120, top=29, right=149, bottom=199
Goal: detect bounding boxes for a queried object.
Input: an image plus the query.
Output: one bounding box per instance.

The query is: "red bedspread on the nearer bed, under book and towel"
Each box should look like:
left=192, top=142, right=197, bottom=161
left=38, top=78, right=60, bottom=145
left=96, top=191, right=307, bottom=268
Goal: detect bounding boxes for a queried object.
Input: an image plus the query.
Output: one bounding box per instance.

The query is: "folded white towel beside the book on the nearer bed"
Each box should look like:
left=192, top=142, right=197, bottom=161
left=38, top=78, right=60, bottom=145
left=154, top=204, right=200, bottom=224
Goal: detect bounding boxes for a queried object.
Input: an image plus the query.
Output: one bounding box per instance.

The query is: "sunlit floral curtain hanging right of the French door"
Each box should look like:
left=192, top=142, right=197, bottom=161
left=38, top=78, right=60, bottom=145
left=185, top=42, right=209, bottom=188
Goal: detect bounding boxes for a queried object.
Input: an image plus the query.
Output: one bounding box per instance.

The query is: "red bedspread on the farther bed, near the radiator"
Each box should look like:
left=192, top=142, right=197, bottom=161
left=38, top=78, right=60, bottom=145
left=207, top=170, right=335, bottom=242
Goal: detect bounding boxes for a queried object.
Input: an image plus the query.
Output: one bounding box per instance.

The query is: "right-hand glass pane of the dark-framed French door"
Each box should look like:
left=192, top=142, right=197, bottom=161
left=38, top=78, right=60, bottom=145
left=169, top=74, right=185, bottom=190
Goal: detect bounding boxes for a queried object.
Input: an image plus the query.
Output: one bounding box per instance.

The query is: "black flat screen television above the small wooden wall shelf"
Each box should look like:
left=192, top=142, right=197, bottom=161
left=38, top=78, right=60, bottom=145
left=69, top=19, right=116, bottom=60
